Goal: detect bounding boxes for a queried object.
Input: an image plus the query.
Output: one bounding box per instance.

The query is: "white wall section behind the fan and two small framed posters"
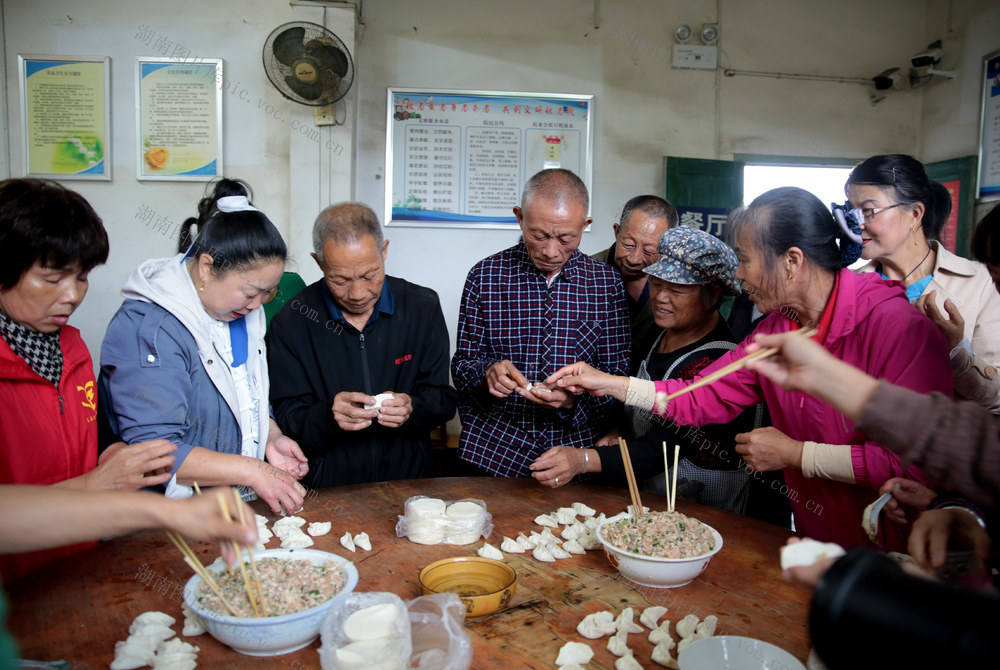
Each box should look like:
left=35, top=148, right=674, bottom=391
left=3, top=0, right=354, bottom=362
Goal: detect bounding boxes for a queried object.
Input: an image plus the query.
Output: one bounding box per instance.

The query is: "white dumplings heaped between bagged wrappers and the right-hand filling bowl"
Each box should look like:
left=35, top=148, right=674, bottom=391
left=477, top=503, right=607, bottom=563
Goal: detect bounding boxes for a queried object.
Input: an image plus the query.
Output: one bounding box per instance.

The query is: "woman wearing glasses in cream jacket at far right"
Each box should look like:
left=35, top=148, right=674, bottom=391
left=846, top=154, right=1000, bottom=413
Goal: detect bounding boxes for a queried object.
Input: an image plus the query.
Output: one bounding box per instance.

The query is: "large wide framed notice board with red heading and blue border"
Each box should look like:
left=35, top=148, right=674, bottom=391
left=385, top=88, right=594, bottom=228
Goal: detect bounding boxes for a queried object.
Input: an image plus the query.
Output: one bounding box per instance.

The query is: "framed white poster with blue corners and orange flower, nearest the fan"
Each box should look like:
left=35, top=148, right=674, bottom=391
left=136, top=58, right=222, bottom=181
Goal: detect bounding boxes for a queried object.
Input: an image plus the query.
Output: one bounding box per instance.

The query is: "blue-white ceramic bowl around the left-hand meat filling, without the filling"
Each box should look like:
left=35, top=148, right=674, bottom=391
left=184, top=549, right=358, bottom=656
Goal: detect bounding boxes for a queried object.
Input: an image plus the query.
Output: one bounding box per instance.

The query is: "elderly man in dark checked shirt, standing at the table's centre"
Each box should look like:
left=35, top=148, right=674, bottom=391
left=451, top=169, right=631, bottom=487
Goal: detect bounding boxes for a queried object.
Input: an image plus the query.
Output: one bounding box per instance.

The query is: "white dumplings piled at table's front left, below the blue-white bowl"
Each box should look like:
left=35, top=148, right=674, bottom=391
left=109, top=612, right=205, bottom=670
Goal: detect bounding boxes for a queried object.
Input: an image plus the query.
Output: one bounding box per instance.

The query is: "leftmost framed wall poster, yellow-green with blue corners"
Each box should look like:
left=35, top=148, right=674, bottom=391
left=17, top=54, right=111, bottom=181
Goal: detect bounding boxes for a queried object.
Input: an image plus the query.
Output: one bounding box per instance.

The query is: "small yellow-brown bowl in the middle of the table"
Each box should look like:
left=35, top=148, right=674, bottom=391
left=420, top=556, right=517, bottom=619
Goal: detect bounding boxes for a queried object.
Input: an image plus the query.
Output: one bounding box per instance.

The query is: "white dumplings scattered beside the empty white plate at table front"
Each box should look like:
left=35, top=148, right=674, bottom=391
left=556, top=605, right=718, bottom=670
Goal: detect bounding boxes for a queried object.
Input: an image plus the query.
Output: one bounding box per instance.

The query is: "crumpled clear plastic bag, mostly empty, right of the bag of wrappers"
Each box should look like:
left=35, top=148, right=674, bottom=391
left=406, top=593, right=472, bottom=670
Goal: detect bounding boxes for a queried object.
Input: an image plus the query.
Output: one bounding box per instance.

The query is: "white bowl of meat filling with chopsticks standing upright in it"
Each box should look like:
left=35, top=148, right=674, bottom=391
left=597, top=512, right=722, bottom=588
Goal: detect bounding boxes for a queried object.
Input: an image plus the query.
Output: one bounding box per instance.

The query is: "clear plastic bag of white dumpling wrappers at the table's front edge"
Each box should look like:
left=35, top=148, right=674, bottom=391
left=319, top=591, right=411, bottom=670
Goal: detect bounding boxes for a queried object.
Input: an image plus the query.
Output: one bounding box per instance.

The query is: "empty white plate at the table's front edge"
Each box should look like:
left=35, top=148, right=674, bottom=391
left=677, top=635, right=806, bottom=670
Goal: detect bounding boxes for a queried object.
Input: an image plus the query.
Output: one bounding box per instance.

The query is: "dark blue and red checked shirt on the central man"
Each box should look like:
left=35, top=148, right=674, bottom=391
left=451, top=242, right=631, bottom=477
